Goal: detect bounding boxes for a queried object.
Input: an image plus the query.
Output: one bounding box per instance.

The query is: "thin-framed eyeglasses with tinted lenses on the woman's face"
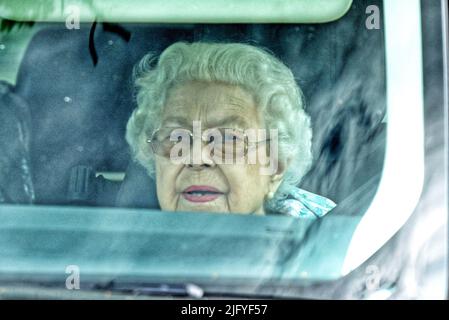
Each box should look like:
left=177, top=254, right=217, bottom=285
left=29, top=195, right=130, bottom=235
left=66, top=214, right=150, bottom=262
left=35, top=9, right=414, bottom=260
left=147, top=127, right=270, bottom=161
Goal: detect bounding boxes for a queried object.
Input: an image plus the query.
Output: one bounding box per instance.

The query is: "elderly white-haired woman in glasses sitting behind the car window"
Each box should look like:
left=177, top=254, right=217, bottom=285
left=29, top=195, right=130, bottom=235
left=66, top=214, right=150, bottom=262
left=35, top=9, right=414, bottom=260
left=126, top=42, right=335, bottom=217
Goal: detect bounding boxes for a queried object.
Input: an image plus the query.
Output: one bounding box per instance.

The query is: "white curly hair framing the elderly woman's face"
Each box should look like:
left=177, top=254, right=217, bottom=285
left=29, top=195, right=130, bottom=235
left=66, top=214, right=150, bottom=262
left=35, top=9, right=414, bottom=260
left=126, top=42, right=312, bottom=199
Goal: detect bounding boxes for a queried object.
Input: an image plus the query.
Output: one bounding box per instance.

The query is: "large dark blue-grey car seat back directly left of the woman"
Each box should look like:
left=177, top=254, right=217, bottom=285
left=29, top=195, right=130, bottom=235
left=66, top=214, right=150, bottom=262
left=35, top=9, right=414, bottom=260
left=15, top=24, right=135, bottom=203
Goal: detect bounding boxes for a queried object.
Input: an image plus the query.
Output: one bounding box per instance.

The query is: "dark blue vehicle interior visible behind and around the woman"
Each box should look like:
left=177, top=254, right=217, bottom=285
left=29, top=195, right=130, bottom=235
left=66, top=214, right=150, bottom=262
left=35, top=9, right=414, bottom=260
left=0, top=1, right=386, bottom=214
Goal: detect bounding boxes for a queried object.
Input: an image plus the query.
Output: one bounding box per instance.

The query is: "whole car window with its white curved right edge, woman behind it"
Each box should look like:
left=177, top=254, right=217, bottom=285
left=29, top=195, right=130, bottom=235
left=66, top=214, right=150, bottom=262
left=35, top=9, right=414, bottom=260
left=0, top=1, right=442, bottom=296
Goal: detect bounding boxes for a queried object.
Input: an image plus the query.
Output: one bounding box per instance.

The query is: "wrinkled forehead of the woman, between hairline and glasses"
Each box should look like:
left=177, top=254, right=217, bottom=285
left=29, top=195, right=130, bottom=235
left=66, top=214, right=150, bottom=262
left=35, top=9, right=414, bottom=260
left=162, top=81, right=263, bottom=129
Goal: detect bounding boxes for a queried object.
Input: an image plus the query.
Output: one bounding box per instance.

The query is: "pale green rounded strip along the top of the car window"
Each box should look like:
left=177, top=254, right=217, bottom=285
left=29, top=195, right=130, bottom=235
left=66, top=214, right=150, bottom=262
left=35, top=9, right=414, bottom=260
left=0, top=0, right=352, bottom=23
